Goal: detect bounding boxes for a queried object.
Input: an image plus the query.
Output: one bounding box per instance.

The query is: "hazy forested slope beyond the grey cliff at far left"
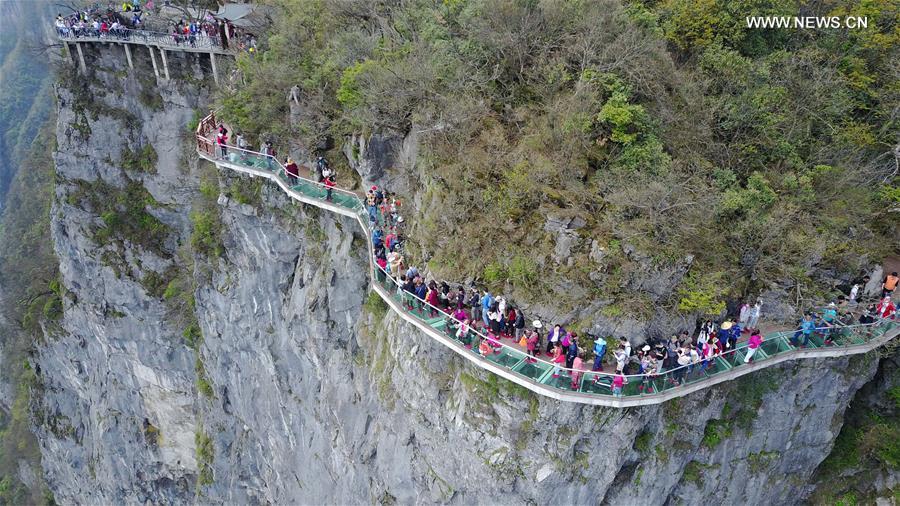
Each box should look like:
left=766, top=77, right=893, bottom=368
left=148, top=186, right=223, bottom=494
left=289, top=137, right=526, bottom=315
left=0, top=117, right=56, bottom=504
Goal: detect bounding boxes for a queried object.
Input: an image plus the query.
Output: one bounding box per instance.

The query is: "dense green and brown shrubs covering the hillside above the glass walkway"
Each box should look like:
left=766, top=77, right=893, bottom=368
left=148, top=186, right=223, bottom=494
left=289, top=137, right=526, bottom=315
left=219, top=0, right=900, bottom=314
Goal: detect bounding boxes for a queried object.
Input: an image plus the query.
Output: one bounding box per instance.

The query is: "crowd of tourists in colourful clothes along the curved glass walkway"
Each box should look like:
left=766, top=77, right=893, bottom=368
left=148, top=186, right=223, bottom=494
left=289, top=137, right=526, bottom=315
left=206, top=121, right=900, bottom=396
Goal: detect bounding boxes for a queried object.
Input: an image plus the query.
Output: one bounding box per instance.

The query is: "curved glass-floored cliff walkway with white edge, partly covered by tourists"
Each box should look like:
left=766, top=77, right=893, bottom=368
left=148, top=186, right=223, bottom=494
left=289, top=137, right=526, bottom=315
left=196, top=113, right=900, bottom=407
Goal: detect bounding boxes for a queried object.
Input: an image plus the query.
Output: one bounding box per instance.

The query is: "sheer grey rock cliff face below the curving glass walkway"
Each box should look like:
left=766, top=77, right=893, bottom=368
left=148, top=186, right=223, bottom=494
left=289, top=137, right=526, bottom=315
left=36, top=42, right=892, bottom=504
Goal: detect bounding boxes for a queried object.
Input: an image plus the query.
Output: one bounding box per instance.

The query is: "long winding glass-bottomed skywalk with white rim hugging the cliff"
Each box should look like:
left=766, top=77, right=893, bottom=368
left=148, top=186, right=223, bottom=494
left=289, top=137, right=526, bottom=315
left=196, top=114, right=900, bottom=407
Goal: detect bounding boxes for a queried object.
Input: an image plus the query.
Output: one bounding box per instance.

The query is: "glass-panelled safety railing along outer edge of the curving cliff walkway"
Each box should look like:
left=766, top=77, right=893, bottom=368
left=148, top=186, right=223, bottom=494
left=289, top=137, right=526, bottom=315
left=196, top=113, right=900, bottom=405
